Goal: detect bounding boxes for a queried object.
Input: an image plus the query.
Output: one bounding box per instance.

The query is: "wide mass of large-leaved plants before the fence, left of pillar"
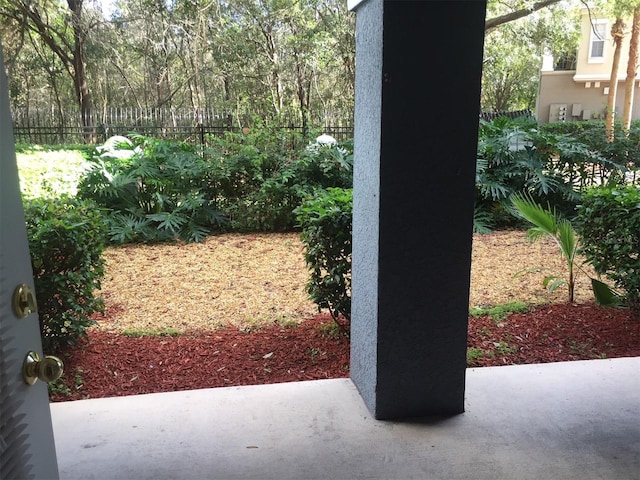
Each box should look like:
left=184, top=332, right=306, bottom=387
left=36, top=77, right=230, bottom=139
left=78, top=128, right=353, bottom=244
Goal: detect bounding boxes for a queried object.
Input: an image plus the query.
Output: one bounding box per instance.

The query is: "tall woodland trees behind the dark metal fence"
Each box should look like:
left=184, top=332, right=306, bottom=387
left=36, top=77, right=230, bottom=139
left=0, top=0, right=600, bottom=128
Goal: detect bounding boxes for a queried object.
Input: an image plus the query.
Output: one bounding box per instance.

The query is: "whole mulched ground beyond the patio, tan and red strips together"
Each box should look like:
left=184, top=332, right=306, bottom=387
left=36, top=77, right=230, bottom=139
left=47, top=231, right=640, bottom=401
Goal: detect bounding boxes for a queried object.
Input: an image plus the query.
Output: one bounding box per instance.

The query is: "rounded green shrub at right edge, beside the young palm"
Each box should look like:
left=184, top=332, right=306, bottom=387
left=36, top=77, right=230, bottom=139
left=577, top=186, right=640, bottom=310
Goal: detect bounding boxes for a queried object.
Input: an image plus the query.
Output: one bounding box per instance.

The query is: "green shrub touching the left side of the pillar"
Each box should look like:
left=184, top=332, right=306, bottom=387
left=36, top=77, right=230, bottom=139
left=296, top=188, right=353, bottom=325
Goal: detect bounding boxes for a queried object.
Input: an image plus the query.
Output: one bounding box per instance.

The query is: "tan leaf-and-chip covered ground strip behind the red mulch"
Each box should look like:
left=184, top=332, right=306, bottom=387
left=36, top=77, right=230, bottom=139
left=98, top=230, right=593, bottom=333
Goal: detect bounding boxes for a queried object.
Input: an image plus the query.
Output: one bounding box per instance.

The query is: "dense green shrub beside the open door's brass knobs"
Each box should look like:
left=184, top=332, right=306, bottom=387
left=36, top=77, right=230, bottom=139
left=25, top=196, right=106, bottom=352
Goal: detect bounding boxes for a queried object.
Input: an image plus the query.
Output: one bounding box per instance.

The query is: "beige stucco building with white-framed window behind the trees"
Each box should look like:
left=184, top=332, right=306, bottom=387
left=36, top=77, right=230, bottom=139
left=536, top=9, right=640, bottom=123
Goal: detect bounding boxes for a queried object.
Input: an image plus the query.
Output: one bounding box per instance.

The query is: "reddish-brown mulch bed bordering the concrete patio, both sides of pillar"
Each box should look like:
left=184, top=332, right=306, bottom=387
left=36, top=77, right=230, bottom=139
left=51, top=304, right=640, bottom=401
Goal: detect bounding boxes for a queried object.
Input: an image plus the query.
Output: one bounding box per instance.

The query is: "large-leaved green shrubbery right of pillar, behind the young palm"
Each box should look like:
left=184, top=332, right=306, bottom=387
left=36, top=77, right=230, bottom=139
left=476, top=118, right=633, bottom=231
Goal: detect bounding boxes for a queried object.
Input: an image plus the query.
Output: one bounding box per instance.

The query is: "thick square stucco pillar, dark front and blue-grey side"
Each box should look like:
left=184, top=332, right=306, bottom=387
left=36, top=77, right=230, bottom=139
left=350, top=0, right=486, bottom=419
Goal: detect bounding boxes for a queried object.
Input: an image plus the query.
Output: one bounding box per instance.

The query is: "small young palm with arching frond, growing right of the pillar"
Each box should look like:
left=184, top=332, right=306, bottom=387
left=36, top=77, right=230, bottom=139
left=511, top=193, right=620, bottom=305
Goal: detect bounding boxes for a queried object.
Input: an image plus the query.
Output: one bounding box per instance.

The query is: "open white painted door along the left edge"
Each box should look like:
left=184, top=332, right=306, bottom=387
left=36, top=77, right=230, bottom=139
left=0, top=47, right=58, bottom=480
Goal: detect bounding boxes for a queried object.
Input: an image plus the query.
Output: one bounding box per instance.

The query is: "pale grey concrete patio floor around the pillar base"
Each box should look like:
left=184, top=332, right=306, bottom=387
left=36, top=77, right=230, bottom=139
left=51, top=358, right=640, bottom=480
